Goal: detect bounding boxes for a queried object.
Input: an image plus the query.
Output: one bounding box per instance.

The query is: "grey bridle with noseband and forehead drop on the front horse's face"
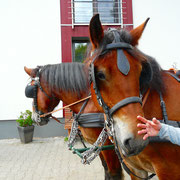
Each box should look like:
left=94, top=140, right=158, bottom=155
left=89, top=31, right=142, bottom=136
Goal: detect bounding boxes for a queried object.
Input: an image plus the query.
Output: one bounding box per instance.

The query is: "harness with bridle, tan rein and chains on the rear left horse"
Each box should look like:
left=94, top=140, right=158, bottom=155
left=25, top=67, right=114, bottom=164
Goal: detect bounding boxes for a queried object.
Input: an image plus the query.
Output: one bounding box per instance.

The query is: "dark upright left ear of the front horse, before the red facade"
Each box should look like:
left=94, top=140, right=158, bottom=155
left=89, top=14, right=104, bottom=48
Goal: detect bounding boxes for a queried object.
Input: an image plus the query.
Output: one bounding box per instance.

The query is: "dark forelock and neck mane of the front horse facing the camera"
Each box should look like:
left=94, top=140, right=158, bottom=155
left=88, top=28, right=165, bottom=92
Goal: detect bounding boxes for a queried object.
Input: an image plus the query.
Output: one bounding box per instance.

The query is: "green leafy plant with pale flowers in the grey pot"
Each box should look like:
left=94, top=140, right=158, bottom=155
left=16, top=110, right=34, bottom=127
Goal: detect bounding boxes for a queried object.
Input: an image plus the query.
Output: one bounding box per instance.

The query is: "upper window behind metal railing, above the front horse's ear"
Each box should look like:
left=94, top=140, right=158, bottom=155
left=72, top=0, right=121, bottom=24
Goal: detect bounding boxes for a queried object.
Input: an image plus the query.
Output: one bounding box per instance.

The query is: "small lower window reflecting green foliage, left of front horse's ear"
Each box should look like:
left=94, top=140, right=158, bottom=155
left=72, top=40, right=89, bottom=62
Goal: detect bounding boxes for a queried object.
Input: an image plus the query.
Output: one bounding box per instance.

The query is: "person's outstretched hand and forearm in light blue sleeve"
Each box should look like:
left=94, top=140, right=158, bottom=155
left=137, top=116, right=180, bottom=145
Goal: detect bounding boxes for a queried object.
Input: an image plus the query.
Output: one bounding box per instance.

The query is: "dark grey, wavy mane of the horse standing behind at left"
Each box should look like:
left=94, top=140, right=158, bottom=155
left=37, top=63, right=89, bottom=95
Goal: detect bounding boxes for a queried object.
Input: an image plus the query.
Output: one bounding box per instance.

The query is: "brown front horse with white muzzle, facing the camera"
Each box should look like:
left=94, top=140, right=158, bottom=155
left=85, top=15, right=180, bottom=180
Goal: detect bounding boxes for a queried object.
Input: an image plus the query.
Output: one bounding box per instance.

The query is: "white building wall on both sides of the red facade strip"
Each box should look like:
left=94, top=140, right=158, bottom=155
left=0, top=0, right=180, bottom=120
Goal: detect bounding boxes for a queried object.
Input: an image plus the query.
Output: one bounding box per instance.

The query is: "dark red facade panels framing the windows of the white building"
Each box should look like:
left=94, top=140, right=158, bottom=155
left=60, top=0, right=133, bottom=121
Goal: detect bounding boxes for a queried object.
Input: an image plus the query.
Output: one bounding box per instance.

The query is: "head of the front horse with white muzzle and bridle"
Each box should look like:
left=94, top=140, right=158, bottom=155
left=89, top=15, right=152, bottom=156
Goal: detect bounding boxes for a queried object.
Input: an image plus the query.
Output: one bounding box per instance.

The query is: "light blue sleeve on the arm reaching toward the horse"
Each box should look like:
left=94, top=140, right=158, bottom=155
left=158, top=124, right=180, bottom=146
